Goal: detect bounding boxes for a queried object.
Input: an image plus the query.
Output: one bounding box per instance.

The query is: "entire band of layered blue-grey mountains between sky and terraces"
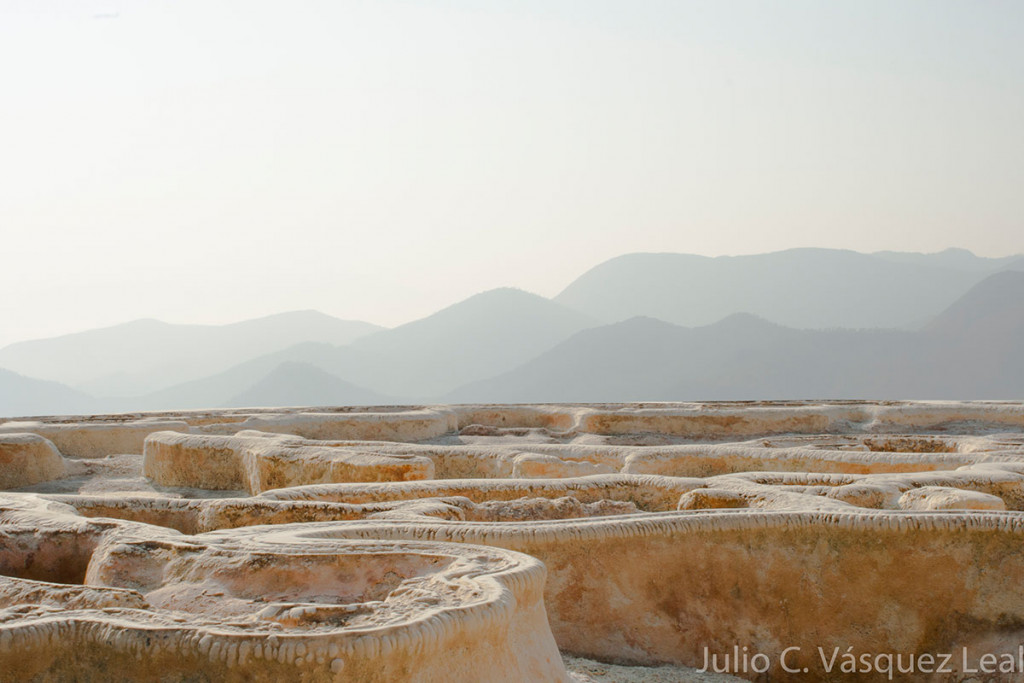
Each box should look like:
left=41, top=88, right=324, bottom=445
left=0, top=249, right=1024, bottom=416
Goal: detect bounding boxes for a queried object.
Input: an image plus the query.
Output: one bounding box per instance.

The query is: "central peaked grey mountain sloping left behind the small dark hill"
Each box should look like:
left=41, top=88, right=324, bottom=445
left=133, top=288, right=597, bottom=410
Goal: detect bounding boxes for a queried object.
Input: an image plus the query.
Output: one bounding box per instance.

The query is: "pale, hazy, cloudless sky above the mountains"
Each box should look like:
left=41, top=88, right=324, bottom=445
left=0, top=0, right=1024, bottom=345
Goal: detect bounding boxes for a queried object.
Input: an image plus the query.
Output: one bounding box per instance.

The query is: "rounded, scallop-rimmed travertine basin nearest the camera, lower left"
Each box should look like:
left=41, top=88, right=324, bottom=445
left=0, top=496, right=565, bottom=681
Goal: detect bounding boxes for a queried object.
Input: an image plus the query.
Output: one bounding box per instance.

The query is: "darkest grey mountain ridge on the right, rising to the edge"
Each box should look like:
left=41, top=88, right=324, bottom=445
left=454, top=271, right=1024, bottom=402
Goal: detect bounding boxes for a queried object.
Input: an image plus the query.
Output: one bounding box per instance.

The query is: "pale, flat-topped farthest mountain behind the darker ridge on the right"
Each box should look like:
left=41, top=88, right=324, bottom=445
left=555, top=249, right=1024, bottom=329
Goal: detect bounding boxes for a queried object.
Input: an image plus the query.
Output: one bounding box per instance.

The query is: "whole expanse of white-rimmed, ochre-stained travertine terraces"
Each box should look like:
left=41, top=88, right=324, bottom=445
left=0, top=402, right=1024, bottom=681
